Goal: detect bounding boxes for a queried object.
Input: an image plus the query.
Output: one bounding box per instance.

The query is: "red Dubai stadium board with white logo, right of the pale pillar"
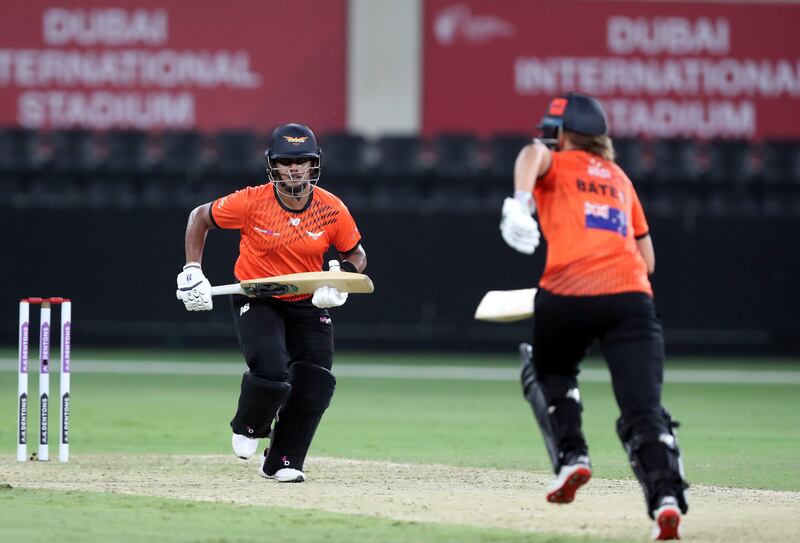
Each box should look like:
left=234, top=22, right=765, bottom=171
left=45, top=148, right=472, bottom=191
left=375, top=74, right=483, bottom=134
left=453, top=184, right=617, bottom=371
left=423, top=0, right=800, bottom=138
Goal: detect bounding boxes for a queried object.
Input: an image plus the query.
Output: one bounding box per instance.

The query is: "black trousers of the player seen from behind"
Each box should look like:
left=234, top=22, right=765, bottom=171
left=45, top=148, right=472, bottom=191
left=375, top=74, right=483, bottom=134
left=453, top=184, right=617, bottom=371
left=533, top=289, right=664, bottom=444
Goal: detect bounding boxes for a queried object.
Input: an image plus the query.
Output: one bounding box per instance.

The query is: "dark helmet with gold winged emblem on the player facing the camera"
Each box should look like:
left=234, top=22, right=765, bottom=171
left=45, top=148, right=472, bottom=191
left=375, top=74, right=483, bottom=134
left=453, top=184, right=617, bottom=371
left=264, top=123, right=322, bottom=196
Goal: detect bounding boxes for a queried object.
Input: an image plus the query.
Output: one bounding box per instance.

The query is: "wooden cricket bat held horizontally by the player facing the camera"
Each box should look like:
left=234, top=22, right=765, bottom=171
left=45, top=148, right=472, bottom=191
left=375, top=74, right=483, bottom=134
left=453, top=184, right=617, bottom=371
left=177, top=271, right=375, bottom=298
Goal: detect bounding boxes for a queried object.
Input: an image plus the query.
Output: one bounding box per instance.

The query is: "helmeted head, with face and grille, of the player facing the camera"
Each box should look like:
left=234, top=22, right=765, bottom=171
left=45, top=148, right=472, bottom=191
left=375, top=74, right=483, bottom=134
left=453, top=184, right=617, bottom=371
left=264, top=123, right=322, bottom=198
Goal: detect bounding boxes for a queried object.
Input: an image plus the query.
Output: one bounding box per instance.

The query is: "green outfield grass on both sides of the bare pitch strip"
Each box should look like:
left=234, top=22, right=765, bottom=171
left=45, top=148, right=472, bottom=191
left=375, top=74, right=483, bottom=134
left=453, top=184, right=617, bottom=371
left=0, top=351, right=800, bottom=542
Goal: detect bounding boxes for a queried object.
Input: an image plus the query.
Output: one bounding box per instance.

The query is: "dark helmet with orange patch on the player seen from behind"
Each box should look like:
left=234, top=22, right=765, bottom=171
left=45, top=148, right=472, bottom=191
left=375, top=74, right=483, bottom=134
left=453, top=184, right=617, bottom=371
left=538, top=92, right=608, bottom=145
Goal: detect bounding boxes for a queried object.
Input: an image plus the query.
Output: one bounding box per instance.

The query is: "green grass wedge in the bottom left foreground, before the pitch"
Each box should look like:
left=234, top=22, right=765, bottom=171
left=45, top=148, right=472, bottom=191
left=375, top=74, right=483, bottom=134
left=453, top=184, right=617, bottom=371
left=0, top=488, right=616, bottom=543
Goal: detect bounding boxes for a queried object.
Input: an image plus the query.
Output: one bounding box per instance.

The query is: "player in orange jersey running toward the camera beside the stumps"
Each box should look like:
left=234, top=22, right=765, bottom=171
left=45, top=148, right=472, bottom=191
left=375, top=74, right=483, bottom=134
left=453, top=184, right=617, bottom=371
left=177, top=124, right=367, bottom=482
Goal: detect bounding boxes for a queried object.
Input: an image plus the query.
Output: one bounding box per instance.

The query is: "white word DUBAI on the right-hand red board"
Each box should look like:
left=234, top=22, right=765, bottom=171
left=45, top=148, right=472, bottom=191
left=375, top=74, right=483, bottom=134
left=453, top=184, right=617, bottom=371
left=606, top=16, right=731, bottom=55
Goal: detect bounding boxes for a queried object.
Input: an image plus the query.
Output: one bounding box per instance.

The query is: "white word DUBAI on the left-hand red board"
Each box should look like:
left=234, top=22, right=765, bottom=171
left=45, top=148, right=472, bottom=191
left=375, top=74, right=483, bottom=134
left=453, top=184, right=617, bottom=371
left=42, top=8, right=168, bottom=46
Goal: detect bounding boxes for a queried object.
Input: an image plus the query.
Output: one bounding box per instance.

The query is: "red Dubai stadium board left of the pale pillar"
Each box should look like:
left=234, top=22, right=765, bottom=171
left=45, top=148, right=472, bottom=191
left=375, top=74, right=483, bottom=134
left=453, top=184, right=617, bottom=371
left=0, top=0, right=346, bottom=130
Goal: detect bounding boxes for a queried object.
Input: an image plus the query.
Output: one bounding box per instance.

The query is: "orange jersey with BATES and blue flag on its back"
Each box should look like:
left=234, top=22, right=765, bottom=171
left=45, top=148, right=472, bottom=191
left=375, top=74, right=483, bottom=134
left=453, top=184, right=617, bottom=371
left=533, top=150, right=653, bottom=296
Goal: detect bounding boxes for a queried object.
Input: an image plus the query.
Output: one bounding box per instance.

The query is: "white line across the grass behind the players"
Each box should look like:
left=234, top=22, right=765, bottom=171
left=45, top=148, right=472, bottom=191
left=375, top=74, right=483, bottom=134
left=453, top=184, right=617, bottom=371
left=0, top=358, right=800, bottom=385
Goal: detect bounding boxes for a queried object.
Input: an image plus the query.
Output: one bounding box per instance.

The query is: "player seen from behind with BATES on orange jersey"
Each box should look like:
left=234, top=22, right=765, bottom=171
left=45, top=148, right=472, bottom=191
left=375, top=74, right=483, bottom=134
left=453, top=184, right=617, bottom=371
left=500, top=93, right=688, bottom=539
